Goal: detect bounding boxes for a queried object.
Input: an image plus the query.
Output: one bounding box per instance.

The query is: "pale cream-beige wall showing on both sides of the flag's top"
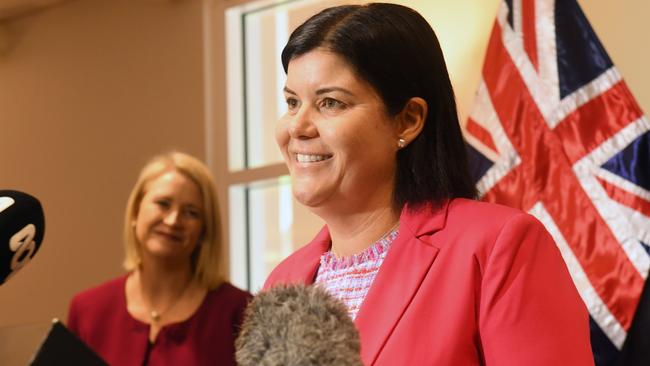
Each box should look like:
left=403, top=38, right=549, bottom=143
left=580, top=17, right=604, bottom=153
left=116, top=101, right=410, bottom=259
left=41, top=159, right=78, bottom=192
left=394, top=0, right=650, bottom=123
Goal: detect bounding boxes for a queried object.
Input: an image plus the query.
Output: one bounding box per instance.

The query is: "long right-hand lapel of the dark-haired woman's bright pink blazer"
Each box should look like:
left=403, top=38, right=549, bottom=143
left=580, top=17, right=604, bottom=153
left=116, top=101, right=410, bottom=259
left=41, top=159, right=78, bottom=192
left=355, top=203, right=447, bottom=365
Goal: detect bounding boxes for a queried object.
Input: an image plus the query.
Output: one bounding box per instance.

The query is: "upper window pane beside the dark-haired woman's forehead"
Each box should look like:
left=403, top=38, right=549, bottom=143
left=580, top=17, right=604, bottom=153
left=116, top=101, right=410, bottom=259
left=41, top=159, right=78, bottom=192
left=226, top=0, right=346, bottom=171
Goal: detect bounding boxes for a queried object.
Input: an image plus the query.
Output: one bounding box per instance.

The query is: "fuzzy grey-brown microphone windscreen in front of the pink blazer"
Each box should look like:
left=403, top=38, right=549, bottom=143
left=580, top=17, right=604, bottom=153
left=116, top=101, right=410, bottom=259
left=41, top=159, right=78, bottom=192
left=235, top=285, right=363, bottom=366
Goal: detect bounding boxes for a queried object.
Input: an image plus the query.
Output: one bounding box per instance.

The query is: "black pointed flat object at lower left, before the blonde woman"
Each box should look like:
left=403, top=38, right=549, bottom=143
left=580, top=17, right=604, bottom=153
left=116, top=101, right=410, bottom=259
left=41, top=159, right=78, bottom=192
left=30, top=319, right=108, bottom=366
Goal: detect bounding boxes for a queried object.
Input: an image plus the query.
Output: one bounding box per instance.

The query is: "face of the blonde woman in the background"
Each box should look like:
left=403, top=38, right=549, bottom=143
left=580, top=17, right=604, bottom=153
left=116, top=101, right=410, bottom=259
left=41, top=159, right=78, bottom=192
left=135, top=170, right=204, bottom=260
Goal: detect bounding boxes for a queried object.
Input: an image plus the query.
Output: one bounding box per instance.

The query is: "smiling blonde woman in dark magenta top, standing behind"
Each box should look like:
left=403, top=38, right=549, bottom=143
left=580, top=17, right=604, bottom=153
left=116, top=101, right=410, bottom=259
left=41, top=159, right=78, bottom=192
left=68, top=152, right=250, bottom=365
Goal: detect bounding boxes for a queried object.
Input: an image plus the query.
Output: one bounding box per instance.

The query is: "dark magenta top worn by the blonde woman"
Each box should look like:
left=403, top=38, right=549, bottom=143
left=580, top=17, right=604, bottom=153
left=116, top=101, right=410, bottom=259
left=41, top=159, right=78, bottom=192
left=68, top=276, right=251, bottom=366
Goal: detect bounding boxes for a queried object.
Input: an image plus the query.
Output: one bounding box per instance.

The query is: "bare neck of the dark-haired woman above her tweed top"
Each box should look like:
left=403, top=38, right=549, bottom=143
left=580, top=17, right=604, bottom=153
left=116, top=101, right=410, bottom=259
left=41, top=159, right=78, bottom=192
left=325, top=207, right=399, bottom=257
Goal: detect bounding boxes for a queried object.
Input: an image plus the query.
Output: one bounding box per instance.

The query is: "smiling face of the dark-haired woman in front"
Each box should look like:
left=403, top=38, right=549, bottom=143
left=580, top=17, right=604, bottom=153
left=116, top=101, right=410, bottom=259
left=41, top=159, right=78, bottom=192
left=276, top=49, right=399, bottom=212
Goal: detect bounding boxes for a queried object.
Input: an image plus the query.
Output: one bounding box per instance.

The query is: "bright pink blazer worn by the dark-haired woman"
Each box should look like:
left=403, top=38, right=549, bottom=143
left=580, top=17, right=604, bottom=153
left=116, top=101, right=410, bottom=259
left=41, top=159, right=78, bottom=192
left=264, top=199, right=594, bottom=366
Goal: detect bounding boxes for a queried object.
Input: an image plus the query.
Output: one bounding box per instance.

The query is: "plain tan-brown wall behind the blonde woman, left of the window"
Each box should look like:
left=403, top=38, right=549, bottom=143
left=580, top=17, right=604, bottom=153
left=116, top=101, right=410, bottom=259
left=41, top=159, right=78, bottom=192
left=0, top=0, right=205, bottom=328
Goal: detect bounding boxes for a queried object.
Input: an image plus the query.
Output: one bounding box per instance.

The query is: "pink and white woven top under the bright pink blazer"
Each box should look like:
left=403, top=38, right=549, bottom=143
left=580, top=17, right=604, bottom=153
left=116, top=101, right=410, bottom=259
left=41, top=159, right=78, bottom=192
left=315, top=229, right=398, bottom=320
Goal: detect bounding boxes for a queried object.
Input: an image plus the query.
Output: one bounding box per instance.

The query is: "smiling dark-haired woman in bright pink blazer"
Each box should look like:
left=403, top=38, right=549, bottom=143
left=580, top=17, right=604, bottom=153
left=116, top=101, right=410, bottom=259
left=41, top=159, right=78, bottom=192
left=265, top=4, right=593, bottom=366
